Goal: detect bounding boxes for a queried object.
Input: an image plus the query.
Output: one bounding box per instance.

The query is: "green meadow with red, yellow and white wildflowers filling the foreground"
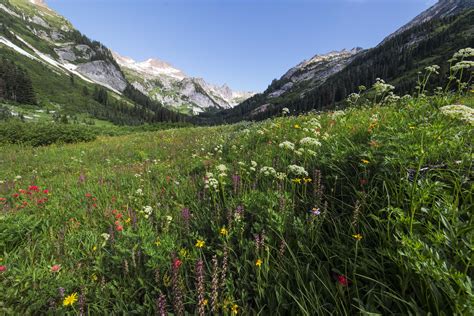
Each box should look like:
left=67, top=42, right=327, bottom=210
left=0, top=66, right=474, bottom=315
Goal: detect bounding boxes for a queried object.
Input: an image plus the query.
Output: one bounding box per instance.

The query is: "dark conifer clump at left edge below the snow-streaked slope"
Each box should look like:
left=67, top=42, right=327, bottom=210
left=0, top=58, right=36, bottom=104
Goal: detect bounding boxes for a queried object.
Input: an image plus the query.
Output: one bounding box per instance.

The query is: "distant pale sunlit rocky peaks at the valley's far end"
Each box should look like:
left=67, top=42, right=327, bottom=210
left=114, top=53, right=254, bottom=114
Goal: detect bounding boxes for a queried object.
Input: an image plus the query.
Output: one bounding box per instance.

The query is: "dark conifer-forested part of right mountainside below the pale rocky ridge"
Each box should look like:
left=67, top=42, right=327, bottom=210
left=210, top=10, right=474, bottom=122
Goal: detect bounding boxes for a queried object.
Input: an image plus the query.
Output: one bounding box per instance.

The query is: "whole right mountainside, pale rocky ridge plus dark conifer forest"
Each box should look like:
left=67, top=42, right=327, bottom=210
left=208, top=0, right=474, bottom=123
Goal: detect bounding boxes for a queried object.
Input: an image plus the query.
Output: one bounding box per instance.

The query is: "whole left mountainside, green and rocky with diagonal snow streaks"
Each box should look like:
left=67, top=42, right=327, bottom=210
left=0, top=0, right=182, bottom=124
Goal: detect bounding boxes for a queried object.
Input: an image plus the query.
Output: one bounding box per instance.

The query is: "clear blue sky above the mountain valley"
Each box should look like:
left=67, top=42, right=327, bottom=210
left=47, top=0, right=436, bottom=91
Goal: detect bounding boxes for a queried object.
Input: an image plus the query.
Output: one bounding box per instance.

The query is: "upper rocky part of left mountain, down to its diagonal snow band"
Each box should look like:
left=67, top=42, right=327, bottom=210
left=0, top=0, right=127, bottom=93
